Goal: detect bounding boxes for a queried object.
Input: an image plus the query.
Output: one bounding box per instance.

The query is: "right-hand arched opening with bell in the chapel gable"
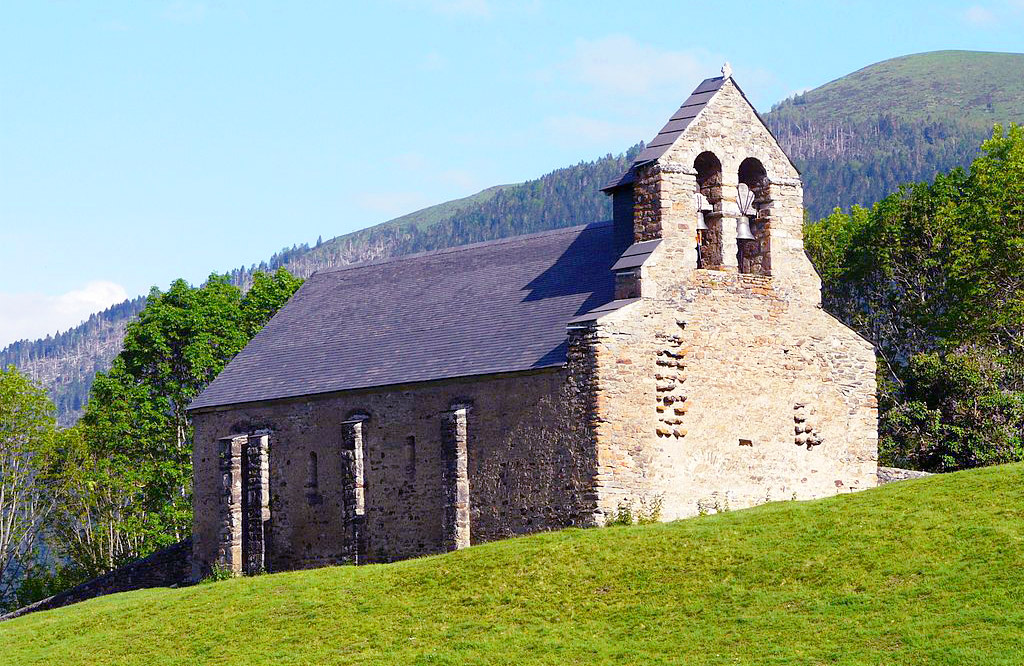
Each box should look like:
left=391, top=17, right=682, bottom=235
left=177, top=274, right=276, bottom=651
left=736, top=157, right=771, bottom=276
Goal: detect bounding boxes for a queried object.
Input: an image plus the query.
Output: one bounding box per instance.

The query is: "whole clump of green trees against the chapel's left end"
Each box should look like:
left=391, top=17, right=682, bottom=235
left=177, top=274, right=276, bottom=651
left=49, top=268, right=302, bottom=575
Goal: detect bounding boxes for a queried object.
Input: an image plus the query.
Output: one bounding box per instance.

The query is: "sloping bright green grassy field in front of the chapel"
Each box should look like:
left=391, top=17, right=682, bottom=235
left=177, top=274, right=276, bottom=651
left=0, top=465, right=1024, bottom=665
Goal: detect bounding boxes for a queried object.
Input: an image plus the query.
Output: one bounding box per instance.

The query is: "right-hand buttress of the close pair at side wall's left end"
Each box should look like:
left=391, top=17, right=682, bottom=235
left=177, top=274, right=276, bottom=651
left=242, top=432, right=270, bottom=576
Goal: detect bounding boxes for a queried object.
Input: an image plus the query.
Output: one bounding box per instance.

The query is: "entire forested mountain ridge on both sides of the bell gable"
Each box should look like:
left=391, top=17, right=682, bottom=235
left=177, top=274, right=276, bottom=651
left=0, top=51, right=1024, bottom=423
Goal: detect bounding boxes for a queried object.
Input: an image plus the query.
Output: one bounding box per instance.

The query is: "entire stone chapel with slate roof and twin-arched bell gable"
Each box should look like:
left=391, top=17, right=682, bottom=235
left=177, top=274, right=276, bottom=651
left=189, top=68, right=878, bottom=578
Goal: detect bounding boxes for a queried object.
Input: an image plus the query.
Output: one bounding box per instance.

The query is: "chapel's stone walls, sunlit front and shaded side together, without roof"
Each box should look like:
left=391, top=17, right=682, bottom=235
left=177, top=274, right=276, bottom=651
left=193, top=73, right=877, bottom=577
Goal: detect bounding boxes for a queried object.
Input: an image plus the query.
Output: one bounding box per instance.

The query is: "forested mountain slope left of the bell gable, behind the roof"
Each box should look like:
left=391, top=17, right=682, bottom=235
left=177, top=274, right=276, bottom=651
left=0, top=149, right=642, bottom=425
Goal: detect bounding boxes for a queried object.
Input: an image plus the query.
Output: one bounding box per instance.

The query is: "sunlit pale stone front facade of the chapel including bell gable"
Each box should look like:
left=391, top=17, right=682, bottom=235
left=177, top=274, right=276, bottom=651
left=588, top=81, right=877, bottom=518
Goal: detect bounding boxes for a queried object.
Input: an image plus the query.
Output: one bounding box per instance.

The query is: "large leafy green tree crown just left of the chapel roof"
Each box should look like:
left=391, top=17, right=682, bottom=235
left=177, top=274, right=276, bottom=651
left=83, top=275, right=248, bottom=545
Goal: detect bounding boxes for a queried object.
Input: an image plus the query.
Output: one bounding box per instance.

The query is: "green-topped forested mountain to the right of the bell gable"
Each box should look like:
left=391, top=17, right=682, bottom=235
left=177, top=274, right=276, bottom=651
left=765, top=51, right=1024, bottom=219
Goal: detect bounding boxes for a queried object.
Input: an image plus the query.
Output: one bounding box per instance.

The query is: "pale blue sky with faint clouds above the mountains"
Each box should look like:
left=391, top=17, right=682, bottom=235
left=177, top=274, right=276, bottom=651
left=0, top=0, right=1024, bottom=346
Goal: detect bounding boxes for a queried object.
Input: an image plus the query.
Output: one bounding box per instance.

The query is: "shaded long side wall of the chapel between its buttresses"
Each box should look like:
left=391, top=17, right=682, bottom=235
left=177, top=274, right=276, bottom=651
left=194, top=370, right=596, bottom=577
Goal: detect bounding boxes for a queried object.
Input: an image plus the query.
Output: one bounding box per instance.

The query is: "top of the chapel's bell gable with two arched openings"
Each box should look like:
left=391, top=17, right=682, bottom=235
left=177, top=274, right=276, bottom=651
left=604, top=63, right=820, bottom=302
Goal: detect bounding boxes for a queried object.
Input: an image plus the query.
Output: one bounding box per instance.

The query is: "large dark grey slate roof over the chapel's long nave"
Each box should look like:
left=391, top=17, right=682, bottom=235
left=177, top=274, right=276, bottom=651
left=189, top=222, right=618, bottom=410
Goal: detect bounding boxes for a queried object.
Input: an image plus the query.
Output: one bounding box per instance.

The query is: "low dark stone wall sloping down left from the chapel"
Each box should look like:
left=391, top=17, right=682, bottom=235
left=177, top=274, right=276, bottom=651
left=0, top=538, right=193, bottom=622
